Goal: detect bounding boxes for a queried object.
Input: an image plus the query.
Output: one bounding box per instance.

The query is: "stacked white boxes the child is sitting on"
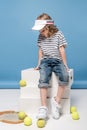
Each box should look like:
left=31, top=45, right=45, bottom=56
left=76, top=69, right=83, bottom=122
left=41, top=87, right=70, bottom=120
left=20, top=68, right=73, bottom=114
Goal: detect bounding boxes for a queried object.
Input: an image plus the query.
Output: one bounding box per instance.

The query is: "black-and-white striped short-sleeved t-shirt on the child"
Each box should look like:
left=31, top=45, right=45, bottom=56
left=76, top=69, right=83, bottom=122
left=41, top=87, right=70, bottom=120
left=38, top=31, right=67, bottom=59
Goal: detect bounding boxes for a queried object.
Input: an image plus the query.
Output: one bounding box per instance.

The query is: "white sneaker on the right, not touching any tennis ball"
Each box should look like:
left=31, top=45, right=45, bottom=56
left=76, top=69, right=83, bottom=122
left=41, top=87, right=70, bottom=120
left=51, top=98, right=61, bottom=119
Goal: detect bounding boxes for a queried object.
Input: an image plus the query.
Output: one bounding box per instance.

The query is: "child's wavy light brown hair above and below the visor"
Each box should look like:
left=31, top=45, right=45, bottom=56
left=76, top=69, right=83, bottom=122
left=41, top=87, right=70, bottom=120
left=37, top=13, right=59, bottom=37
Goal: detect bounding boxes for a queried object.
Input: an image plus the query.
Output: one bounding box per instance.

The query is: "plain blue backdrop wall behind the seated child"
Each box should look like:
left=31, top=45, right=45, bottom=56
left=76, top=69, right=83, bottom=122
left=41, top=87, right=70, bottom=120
left=0, top=0, right=87, bottom=88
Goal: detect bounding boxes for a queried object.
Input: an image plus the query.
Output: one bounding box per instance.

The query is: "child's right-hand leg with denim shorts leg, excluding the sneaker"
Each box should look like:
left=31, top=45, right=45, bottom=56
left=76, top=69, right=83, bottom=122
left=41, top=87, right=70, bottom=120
left=54, top=61, right=69, bottom=104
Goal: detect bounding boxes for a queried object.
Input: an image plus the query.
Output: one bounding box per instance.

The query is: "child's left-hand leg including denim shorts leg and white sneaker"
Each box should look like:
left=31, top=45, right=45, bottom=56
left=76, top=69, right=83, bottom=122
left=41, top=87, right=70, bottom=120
left=37, top=59, right=52, bottom=119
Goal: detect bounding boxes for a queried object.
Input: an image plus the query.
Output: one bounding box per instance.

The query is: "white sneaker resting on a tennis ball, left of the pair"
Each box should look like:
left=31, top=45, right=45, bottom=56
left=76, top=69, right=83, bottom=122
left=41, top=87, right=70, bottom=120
left=37, top=106, right=48, bottom=119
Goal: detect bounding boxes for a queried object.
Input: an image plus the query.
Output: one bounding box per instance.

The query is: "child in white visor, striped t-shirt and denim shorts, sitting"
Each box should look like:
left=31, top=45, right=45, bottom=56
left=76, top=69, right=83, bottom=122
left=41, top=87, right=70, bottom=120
left=32, top=13, right=69, bottom=119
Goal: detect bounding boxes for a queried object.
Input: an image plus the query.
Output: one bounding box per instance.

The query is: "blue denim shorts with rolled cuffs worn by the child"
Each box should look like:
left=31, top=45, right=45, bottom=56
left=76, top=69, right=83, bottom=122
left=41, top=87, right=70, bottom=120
left=38, top=58, right=69, bottom=88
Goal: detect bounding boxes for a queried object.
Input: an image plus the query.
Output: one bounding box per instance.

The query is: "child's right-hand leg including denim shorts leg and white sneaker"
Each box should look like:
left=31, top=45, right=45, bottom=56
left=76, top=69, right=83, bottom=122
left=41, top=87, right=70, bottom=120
left=51, top=61, right=69, bottom=119
